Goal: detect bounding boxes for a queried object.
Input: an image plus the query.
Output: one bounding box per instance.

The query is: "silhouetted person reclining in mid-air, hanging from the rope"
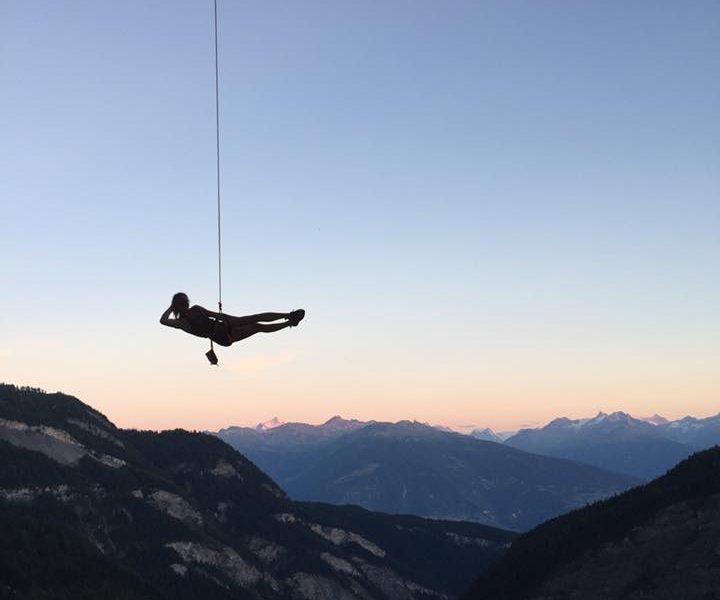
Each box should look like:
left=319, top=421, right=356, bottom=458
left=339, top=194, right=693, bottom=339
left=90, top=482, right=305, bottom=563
left=160, top=292, right=305, bottom=346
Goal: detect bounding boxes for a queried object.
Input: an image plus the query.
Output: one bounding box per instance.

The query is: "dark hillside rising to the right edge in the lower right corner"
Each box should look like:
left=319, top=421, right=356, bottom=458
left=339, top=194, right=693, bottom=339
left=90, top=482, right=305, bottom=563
left=463, top=447, right=720, bottom=600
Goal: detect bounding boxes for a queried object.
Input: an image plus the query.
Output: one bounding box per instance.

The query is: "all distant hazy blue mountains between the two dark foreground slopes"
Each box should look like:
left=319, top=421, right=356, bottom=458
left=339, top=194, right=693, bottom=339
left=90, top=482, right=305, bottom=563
left=217, top=412, right=720, bottom=531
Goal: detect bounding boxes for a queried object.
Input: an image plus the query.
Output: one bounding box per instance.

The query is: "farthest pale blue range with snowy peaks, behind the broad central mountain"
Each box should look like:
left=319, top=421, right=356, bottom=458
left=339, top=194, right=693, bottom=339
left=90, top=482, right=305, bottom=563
left=217, top=412, right=720, bottom=494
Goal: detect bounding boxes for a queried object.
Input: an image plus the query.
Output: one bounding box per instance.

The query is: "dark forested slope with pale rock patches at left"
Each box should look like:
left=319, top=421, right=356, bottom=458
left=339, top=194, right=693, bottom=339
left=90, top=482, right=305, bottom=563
left=0, top=385, right=514, bottom=600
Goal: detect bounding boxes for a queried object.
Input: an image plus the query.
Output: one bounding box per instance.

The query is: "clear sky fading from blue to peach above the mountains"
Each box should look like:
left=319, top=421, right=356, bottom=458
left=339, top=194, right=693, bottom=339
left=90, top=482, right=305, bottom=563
left=0, top=0, right=720, bottom=431
